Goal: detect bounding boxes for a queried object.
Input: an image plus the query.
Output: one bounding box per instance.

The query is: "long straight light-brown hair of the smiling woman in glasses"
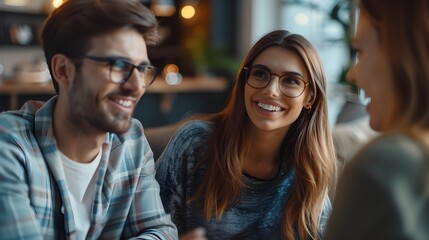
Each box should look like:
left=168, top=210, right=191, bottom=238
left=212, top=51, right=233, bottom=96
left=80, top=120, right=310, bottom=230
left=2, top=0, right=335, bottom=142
left=191, top=30, right=336, bottom=239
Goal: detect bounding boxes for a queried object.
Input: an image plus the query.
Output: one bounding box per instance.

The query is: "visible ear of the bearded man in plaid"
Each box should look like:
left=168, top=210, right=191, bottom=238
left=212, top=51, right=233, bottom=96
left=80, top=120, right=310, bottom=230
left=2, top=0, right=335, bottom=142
left=51, top=54, right=75, bottom=87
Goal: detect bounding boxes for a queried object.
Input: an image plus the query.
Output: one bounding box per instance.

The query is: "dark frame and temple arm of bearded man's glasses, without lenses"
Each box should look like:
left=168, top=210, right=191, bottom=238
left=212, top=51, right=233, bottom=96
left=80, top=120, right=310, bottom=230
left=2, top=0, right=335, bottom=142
left=74, top=55, right=160, bottom=88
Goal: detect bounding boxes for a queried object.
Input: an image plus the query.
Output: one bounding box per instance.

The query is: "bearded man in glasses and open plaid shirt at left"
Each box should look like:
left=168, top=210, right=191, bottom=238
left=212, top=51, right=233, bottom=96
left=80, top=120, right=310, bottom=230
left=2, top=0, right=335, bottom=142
left=0, top=0, right=178, bottom=239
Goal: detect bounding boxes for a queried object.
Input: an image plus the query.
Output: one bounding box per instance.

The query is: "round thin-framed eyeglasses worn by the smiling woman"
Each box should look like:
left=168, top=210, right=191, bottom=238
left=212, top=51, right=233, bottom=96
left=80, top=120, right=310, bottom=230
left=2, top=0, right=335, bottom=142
left=244, top=64, right=309, bottom=98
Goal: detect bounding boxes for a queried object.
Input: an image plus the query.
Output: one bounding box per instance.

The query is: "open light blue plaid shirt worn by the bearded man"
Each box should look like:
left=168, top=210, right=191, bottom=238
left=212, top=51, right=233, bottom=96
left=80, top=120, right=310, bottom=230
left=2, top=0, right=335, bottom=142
left=0, top=97, right=178, bottom=239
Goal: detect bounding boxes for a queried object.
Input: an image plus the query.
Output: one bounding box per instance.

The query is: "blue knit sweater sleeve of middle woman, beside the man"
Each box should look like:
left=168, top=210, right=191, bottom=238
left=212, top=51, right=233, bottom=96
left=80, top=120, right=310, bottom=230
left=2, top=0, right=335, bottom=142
left=156, top=121, right=209, bottom=235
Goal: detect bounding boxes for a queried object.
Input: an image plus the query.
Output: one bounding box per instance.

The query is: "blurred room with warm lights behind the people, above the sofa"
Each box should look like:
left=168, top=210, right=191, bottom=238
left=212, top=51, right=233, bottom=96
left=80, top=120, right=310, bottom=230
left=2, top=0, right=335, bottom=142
left=0, top=0, right=365, bottom=127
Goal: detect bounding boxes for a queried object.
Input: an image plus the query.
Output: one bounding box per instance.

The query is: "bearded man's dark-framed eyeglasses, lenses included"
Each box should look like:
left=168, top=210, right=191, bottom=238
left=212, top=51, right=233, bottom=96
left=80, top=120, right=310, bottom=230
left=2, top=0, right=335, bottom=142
left=81, top=55, right=159, bottom=88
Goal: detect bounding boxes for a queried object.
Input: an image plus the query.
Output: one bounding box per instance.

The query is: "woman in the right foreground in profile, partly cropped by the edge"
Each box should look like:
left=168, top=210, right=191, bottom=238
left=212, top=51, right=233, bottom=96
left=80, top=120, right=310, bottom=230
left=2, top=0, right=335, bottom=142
left=326, top=0, right=429, bottom=240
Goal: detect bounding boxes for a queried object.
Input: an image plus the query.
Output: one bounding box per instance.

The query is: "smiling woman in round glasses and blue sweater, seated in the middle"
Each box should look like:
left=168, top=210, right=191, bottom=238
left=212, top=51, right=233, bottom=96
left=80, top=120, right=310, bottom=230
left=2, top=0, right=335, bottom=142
left=156, top=30, right=335, bottom=240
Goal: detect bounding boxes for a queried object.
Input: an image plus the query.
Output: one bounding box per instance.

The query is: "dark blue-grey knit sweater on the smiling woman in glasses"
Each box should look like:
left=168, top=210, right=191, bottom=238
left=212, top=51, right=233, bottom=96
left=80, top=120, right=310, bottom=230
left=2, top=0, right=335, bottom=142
left=156, top=121, right=331, bottom=240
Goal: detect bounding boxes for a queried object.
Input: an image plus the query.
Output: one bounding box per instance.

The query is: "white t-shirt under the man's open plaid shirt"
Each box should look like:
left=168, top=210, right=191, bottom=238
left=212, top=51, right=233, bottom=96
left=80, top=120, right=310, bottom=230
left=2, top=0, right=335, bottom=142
left=60, top=148, right=101, bottom=239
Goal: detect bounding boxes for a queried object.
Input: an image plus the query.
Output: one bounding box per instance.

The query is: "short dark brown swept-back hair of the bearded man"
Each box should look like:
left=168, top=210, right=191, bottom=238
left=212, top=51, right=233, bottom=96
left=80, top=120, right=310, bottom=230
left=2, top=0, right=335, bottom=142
left=41, top=0, right=158, bottom=93
